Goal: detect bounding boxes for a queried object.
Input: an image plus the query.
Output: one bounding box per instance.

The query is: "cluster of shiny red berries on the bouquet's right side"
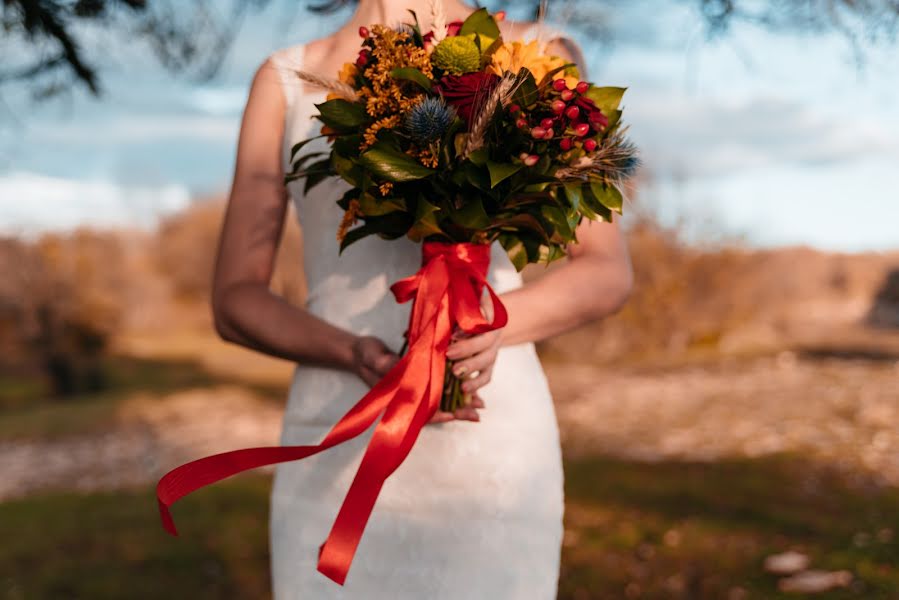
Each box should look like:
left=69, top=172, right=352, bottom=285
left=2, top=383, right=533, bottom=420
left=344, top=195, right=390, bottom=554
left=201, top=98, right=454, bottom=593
left=509, top=79, right=609, bottom=164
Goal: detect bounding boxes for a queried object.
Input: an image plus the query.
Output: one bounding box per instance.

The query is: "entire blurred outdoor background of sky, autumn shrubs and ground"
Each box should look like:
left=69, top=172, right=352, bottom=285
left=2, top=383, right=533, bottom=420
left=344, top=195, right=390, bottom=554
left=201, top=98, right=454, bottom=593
left=0, top=0, right=899, bottom=600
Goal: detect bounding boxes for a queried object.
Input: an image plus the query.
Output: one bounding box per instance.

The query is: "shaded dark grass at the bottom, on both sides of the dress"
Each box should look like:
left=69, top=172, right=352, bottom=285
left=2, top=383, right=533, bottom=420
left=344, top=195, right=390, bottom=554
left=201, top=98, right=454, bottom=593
left=0, top=456, right=899, bottom=600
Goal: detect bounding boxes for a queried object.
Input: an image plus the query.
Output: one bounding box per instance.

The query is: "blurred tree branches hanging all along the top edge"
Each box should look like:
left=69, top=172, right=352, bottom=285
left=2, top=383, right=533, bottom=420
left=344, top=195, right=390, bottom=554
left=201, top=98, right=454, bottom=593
left=0, top=0, right=899, bottom=98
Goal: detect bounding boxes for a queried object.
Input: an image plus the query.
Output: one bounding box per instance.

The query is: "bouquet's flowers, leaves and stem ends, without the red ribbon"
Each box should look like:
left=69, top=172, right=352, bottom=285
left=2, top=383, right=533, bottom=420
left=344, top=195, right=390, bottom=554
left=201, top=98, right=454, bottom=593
left=286, top=9, right=637, bottom=411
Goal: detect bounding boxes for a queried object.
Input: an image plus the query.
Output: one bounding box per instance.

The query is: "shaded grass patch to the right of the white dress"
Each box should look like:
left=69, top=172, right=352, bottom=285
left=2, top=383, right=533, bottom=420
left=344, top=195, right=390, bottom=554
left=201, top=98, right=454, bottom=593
left=560, top=456, right=899, bottom=600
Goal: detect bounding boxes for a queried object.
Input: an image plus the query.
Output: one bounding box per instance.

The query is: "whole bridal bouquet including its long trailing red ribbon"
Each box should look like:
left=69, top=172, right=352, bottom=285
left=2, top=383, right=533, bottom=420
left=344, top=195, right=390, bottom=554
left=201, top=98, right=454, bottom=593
left=157, top=0, right=638, bottom=585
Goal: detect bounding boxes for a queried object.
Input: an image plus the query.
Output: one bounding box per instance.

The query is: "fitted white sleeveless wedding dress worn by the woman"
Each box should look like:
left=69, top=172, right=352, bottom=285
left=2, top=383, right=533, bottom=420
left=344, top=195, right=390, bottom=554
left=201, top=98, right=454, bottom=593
left=270, top=38, right=563, bottom=600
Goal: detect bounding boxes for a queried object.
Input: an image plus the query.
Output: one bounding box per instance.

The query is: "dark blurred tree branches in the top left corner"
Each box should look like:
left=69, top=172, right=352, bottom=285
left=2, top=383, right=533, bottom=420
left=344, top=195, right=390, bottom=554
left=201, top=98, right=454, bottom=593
left=0, top=0, right=269, bottom=99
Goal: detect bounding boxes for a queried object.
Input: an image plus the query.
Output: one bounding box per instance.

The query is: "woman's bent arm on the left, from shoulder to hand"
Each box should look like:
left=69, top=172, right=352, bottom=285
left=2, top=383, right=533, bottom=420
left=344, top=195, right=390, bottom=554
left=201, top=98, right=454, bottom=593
left=212, top=61, right=395, bottom=381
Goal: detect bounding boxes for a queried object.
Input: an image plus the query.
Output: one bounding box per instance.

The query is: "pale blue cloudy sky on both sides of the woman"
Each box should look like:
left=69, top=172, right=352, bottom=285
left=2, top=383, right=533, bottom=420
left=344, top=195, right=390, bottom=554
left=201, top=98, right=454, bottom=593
left=0, top=0, right=899, bottom=251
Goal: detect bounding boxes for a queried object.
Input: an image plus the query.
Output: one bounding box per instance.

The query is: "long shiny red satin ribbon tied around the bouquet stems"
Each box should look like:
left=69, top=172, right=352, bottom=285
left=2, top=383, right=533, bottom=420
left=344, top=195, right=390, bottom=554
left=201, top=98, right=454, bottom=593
left=156, top=242, right=507, bottom=585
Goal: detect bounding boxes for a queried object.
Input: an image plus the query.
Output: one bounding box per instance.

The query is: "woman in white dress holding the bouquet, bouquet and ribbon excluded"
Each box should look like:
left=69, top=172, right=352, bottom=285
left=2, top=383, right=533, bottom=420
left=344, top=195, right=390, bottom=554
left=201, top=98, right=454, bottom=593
left=212, top=0, right=631, bottom=600
